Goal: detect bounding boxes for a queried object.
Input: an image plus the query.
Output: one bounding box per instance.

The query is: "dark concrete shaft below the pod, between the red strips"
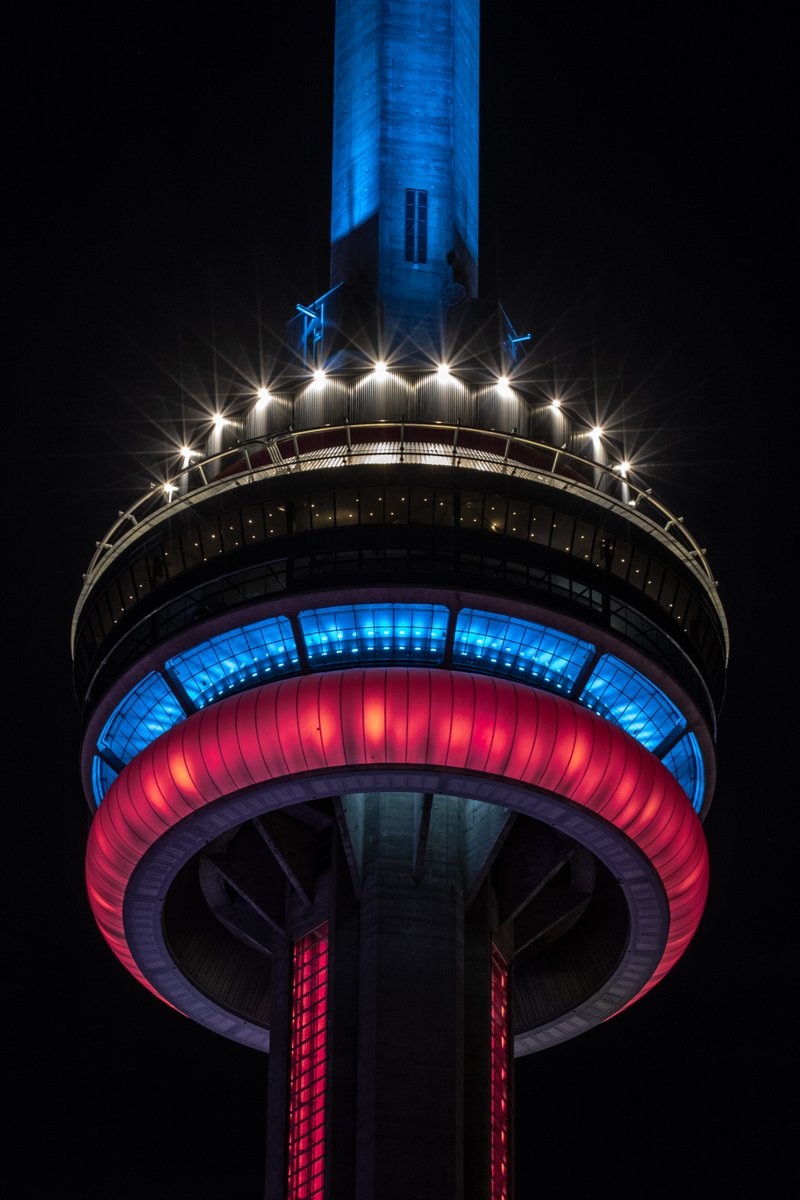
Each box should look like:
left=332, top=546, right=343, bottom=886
left=267, top=792, right=506, bottom=1200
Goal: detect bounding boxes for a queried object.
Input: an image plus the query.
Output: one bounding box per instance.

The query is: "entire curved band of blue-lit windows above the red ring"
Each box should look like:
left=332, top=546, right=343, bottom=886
left=92, top=604, right=705, bottom=812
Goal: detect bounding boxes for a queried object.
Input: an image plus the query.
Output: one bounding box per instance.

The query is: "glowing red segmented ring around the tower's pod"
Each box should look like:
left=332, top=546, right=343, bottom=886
left=86, top=667, right=708, bottom=1032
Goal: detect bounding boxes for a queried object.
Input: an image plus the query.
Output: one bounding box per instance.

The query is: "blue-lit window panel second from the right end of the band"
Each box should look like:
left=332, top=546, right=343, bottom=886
left=578, top=654, right=686, bottom=750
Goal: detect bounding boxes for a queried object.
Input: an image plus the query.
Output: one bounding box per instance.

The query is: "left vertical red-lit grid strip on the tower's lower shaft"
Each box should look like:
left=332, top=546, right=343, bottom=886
left=287, top=924, right=329, bottom=1200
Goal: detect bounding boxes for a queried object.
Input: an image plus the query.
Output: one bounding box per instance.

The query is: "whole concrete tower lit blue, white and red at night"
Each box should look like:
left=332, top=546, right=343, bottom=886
left=72, top=0, right=728, bottom=1200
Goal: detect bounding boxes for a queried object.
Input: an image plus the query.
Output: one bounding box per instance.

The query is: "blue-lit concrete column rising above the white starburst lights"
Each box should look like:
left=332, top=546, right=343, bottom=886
left=331, top=0, right=480, bottom=353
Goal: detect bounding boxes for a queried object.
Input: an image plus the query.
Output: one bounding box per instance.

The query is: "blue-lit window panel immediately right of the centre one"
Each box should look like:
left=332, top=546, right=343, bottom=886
left=453, top=608, right=595, bottom=691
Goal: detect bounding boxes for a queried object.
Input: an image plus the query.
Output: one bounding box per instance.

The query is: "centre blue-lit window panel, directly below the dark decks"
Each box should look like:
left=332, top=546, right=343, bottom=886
left=300, top=604, right=447, bottom=665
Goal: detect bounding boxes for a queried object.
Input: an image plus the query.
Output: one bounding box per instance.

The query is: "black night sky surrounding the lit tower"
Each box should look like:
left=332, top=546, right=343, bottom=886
left=12, top=0, right=799, bottom=1200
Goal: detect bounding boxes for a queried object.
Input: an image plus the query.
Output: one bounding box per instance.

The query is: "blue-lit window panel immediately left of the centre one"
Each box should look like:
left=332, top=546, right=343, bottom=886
left=167, top=617, right=299, bottom=708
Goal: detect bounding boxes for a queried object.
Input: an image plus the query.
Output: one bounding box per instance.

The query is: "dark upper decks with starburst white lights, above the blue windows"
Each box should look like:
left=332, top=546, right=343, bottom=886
left=73, top=370, right=728, bottom=812
